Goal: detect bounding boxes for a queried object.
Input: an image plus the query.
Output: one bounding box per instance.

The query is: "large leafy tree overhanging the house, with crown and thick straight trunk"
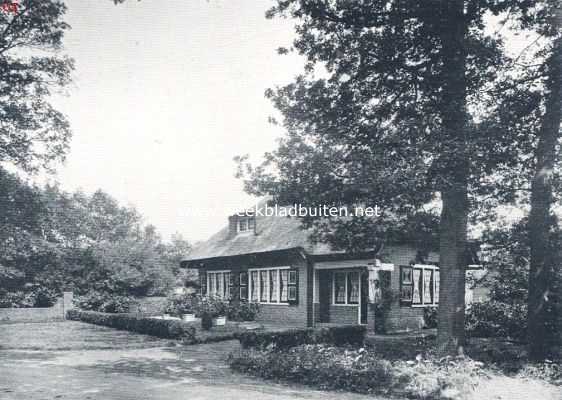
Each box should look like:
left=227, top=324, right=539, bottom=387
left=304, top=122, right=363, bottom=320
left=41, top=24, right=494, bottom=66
left=235, top=0, right=532, bottom=353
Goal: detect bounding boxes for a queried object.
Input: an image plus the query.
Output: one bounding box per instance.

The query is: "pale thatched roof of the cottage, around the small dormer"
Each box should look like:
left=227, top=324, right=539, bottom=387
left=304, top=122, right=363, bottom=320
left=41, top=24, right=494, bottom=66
left=185, top=203, right=337, bottom=262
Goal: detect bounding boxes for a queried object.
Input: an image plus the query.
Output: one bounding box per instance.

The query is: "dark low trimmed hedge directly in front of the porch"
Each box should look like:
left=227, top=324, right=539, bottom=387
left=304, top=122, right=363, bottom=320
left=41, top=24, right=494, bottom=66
left=232, top=325, right=367, bottom=349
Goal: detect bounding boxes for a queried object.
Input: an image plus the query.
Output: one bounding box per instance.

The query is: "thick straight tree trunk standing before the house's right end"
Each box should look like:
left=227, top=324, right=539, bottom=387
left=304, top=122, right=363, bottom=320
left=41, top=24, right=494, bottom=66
left=437, top=0, right=469, bottom=355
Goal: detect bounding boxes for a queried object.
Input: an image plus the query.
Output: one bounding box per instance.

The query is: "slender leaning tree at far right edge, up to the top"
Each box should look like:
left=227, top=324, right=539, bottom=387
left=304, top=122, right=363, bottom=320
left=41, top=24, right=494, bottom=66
left=528, top=2, right=562, bottom=359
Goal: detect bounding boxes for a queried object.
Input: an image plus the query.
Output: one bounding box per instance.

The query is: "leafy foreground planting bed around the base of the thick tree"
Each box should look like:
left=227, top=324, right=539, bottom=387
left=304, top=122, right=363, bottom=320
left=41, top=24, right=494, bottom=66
left=225, top=333, right=562, bottom=399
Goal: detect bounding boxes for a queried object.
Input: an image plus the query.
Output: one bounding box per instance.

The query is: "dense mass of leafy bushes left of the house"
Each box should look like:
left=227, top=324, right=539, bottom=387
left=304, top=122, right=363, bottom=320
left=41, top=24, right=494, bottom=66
left=0, top=169, right=193, bottom=310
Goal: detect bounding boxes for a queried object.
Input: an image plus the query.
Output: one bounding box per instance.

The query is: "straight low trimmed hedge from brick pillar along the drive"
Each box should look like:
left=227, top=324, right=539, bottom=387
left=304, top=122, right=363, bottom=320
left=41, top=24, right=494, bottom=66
left=66, top=310, right=197, bottom=342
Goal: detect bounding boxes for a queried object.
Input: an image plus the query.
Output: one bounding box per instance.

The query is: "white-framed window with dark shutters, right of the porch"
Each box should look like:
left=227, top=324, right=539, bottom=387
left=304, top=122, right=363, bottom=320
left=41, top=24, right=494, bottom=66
left=400, top=264, right=439, bottom=306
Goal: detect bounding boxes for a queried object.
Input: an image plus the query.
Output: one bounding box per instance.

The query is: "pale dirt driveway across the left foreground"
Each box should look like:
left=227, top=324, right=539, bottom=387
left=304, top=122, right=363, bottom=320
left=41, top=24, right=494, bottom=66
left=0, top=322, right=383, bottom=400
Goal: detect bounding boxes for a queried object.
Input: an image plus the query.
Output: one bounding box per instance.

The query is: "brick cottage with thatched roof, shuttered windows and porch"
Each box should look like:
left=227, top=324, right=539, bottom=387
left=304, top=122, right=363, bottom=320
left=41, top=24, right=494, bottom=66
left=181, top=203, right=482, bottom=332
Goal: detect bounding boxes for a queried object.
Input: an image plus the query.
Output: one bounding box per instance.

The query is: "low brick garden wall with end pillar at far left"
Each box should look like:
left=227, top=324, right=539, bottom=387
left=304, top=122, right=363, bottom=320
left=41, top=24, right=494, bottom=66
left=0, top=292, right=73, bottom=323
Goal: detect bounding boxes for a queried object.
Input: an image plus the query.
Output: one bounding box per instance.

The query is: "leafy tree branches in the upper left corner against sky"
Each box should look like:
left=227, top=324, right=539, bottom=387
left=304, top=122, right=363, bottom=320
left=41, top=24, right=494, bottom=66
left=0, top=0, right=73, bottom=171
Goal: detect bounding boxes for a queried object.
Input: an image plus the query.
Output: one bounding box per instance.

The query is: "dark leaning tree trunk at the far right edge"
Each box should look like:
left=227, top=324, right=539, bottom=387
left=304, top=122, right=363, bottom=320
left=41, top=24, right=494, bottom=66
left=528, top=10, right=562, bottom=360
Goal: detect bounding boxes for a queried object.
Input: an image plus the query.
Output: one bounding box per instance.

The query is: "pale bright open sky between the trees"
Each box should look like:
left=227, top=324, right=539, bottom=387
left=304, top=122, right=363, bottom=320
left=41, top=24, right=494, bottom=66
left=48, top=0, right=303, bottom=242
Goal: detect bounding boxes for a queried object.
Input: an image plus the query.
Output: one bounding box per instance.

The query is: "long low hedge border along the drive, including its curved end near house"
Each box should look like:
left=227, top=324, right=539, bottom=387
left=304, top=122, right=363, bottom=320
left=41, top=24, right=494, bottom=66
left=66, top=310, right=256, bottom=344
